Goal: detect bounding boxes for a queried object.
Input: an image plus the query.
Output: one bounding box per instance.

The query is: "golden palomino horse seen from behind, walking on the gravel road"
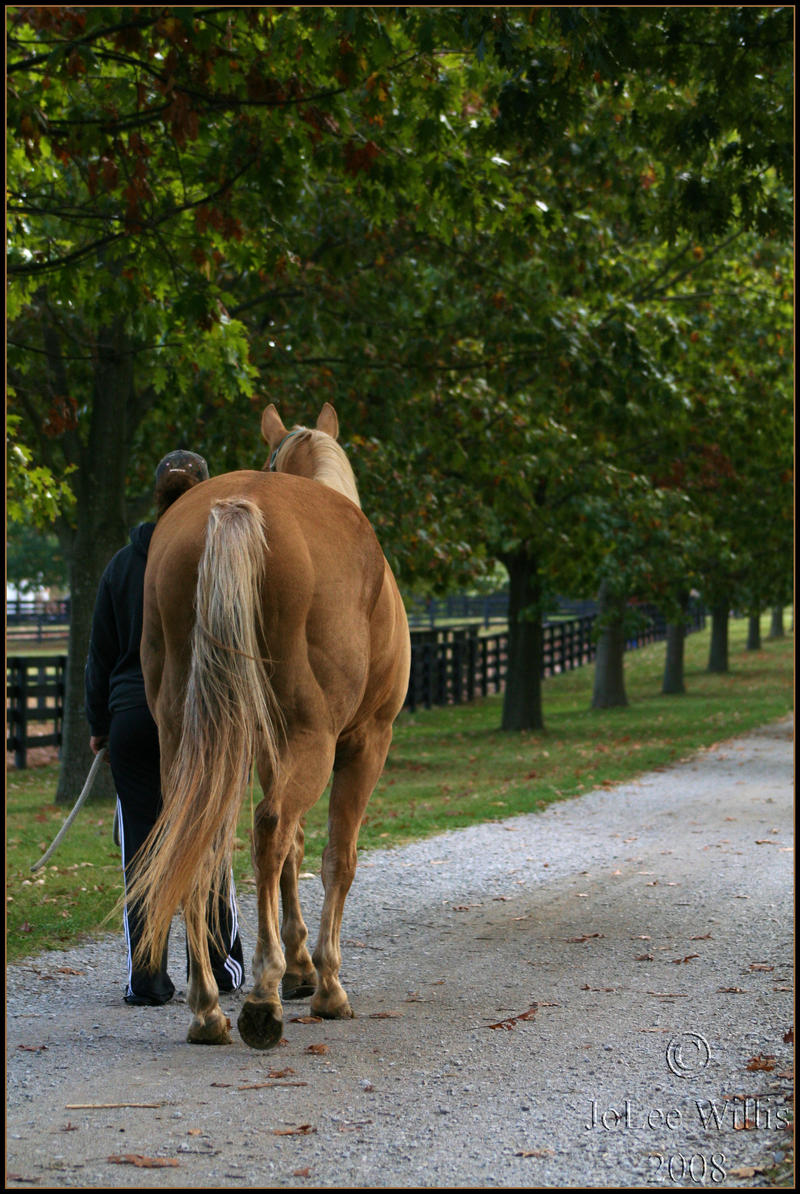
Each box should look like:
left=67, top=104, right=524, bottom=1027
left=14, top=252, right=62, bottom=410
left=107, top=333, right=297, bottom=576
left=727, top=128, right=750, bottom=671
left=129, top=404, right=411, bottom=1048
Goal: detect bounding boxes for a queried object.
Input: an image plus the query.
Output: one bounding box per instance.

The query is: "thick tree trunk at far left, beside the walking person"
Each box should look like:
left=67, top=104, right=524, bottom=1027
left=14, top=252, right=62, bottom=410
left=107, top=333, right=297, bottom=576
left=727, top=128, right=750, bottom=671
left=56, top=330, right=135, bottom=804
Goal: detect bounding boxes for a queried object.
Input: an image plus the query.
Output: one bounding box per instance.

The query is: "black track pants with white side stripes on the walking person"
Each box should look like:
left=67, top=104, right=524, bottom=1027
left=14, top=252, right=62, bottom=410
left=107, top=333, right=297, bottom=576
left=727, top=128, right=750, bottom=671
left=109, top=706, right=245, bottom=1004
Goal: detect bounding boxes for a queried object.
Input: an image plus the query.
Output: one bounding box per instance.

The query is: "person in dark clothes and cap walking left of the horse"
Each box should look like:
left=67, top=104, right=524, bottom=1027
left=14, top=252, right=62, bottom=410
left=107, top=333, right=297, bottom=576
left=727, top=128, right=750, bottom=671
left=85, top=449, right=245, bottom=1007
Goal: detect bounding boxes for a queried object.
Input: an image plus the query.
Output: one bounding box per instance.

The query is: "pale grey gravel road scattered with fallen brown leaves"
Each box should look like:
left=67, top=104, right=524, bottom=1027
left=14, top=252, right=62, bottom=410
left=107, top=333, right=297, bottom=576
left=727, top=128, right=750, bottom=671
left=6, top=718, right=794, bottom=1189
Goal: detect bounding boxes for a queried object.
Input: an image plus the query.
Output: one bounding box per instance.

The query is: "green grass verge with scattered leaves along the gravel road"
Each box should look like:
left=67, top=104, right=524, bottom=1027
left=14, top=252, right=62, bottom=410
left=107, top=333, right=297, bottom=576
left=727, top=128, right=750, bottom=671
left=6, top=616, right=794, bottom=960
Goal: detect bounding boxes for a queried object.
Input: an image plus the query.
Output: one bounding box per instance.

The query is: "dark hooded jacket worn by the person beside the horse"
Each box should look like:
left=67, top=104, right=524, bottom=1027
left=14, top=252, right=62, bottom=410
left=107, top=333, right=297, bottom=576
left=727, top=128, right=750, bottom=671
left=85, top=523, right=155, bottom=737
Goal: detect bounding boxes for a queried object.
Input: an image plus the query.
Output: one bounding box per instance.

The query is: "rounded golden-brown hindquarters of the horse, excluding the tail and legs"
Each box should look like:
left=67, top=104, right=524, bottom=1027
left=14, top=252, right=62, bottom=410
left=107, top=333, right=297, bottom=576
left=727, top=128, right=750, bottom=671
left=142, top=470, right=407, bottom=727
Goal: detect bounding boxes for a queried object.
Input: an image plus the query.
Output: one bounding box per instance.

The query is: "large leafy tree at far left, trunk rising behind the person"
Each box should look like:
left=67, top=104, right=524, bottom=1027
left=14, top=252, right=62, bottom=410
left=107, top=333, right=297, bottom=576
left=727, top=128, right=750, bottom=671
left=7, top=8, right=503, bottom=799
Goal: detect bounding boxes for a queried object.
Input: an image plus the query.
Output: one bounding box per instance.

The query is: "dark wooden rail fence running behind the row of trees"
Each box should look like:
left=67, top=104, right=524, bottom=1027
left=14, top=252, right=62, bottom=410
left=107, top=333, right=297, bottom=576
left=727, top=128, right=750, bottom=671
left=6, top=605, right=706, bottom=768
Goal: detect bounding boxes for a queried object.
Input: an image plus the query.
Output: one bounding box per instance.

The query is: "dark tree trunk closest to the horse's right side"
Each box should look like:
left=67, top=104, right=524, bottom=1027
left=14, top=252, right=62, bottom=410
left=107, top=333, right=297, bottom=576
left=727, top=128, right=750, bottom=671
left=501, top=553, right=544, bottom=730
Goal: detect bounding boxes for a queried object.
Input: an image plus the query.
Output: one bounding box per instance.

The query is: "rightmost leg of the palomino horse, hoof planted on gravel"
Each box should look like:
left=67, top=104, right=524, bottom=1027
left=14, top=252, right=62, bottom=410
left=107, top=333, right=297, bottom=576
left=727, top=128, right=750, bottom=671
left=310, top=726, right=392, bottom=1020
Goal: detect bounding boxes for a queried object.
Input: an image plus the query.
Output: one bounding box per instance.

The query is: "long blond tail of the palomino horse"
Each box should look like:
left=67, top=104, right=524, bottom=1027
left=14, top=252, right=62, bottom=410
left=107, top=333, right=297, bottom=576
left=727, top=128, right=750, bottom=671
left=128, top=498, right=282, bottom=966
